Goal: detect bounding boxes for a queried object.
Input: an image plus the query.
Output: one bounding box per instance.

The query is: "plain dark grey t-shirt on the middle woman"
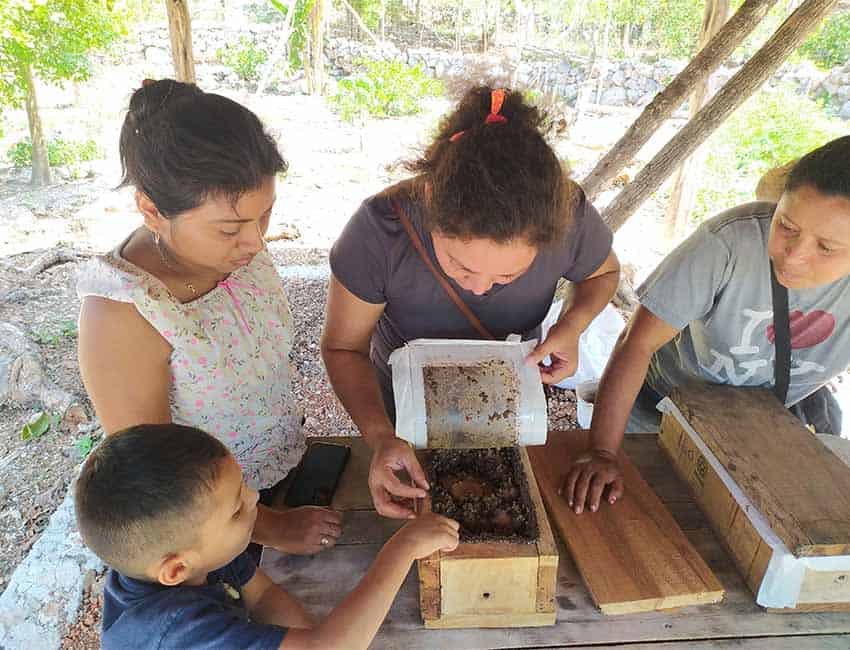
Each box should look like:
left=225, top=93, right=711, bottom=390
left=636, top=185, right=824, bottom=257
left=330, top=187, right=613, bottom=400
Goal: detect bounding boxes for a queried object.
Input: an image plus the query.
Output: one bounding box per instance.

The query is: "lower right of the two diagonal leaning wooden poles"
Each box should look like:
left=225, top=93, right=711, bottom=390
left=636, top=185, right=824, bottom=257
left=603, top=0, right=838, bottom=230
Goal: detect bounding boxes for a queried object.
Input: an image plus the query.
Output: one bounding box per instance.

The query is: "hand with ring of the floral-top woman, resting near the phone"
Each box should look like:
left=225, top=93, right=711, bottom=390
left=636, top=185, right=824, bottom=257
left=254, top=506, right=342, bottom=555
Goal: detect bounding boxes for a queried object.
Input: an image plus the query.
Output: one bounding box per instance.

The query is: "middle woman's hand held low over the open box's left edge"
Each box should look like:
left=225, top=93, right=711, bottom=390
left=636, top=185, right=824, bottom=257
left=369, top=437, right=429, bottom=519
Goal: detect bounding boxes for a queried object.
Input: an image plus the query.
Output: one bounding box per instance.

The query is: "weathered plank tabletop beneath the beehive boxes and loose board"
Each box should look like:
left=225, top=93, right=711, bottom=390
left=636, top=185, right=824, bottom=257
left=262, top=432, right=850, bottom=650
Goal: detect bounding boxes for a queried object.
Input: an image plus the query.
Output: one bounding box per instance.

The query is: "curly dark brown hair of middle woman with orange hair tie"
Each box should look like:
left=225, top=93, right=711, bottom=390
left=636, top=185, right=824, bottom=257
left=407, top=86, right=580, bottom=246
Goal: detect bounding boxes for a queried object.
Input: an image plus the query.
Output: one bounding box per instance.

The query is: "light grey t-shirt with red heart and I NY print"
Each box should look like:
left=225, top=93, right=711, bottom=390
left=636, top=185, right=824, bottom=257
left=638, top=202, right=850, bottom=406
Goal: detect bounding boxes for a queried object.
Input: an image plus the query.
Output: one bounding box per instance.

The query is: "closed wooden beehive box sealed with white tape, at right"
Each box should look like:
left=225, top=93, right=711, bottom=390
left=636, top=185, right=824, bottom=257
left=659, top=386, right=850, bottom=611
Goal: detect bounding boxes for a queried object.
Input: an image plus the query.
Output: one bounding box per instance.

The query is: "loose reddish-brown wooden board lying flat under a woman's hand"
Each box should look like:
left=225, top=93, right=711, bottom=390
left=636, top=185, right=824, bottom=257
left=527, top=431, right=724, bottom=614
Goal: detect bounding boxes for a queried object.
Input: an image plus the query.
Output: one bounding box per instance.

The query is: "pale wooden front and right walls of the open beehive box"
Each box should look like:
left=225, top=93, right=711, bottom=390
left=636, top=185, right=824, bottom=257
left=418, top=447, right=558, bottom=628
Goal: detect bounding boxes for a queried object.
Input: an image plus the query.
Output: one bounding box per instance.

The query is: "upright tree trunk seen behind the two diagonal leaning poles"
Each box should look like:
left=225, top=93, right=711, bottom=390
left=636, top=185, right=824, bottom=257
left=664, top=0, right=729, bottom=242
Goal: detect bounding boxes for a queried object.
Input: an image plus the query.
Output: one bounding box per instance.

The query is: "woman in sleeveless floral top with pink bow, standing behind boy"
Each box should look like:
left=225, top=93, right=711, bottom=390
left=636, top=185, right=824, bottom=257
left=78, top=79, right=341, bottom=553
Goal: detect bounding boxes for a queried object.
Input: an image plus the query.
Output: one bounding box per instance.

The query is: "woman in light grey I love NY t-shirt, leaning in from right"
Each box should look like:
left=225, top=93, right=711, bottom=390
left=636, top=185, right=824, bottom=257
left=564, top=136, right=850, bottom=513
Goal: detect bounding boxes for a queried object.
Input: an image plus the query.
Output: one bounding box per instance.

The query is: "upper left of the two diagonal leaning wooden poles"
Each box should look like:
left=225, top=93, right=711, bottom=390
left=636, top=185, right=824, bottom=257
left=581, top=0, right=776, bottom=199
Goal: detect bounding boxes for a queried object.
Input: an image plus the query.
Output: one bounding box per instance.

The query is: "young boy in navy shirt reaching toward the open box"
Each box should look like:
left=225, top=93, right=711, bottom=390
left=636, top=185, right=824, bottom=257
left=76, top=424, right=458, bottom=650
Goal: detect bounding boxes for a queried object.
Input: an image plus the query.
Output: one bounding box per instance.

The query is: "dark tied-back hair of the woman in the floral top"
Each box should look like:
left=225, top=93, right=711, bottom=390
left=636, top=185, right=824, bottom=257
left=119, top=79, right=288, bottom=218
